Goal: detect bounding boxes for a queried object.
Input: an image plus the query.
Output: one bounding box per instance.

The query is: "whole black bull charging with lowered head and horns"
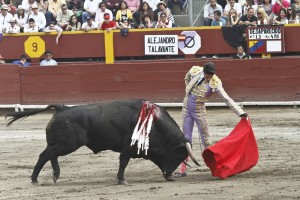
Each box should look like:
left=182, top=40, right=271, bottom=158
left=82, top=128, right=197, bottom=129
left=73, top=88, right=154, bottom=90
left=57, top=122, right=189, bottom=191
left=6, top=100, right=199, bottom=184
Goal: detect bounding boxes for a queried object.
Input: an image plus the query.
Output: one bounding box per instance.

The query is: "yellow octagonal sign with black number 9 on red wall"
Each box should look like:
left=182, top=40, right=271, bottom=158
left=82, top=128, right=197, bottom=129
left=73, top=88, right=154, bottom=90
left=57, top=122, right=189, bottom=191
left=24, top=36, right=45, bottom=58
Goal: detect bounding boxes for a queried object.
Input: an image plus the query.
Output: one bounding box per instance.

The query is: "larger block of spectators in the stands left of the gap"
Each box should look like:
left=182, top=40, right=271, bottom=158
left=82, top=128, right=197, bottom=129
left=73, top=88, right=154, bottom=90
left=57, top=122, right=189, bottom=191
left=0, top=0, right=186, bottom=34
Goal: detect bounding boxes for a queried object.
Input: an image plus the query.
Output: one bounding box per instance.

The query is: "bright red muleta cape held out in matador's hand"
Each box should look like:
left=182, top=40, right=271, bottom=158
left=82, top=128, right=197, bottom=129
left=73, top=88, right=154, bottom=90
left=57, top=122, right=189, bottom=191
left=202, top=118, right=258, bottom=179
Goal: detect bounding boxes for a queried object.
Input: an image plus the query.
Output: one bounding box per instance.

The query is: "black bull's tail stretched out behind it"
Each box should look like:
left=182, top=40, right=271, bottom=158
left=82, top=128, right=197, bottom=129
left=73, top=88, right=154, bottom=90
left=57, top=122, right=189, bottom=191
left=5, top=105, right=69, bottom=126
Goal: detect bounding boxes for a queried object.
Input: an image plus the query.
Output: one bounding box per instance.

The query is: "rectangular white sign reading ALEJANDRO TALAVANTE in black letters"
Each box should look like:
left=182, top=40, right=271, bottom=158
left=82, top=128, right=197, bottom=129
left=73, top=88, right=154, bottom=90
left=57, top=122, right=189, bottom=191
left=145, top=35, right=178, bottom=55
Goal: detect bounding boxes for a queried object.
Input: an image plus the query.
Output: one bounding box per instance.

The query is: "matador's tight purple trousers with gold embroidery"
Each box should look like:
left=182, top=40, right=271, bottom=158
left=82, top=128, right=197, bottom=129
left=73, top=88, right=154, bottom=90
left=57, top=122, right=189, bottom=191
left=179, top=94, right=211, bottom=173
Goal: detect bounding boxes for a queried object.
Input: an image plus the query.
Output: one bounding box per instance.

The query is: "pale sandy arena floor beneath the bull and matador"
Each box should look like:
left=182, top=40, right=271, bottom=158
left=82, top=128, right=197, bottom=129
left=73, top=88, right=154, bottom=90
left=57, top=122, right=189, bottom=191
left=0, top=107, right=300, bottom=200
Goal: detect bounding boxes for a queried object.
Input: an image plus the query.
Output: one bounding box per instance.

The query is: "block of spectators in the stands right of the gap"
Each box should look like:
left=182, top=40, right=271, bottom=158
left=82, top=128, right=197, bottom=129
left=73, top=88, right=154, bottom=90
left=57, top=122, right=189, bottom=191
left=204, top=0, right=300, bottom=26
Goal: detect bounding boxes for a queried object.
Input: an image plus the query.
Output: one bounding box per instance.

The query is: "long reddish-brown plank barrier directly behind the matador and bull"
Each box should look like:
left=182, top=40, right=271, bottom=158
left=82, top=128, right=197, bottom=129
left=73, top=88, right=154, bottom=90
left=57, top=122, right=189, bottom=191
left=0, top=57, right=300, bottom=105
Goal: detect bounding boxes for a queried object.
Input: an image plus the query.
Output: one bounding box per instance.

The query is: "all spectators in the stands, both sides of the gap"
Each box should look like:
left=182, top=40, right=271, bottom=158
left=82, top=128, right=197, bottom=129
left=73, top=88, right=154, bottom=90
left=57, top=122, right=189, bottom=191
left=0, top=0, right=300, bottom=34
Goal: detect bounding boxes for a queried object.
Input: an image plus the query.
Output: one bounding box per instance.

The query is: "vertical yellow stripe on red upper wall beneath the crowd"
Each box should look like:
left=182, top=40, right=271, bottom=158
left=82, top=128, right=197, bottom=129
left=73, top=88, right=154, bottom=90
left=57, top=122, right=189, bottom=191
left=104, top=31, right=115, bottom=64
